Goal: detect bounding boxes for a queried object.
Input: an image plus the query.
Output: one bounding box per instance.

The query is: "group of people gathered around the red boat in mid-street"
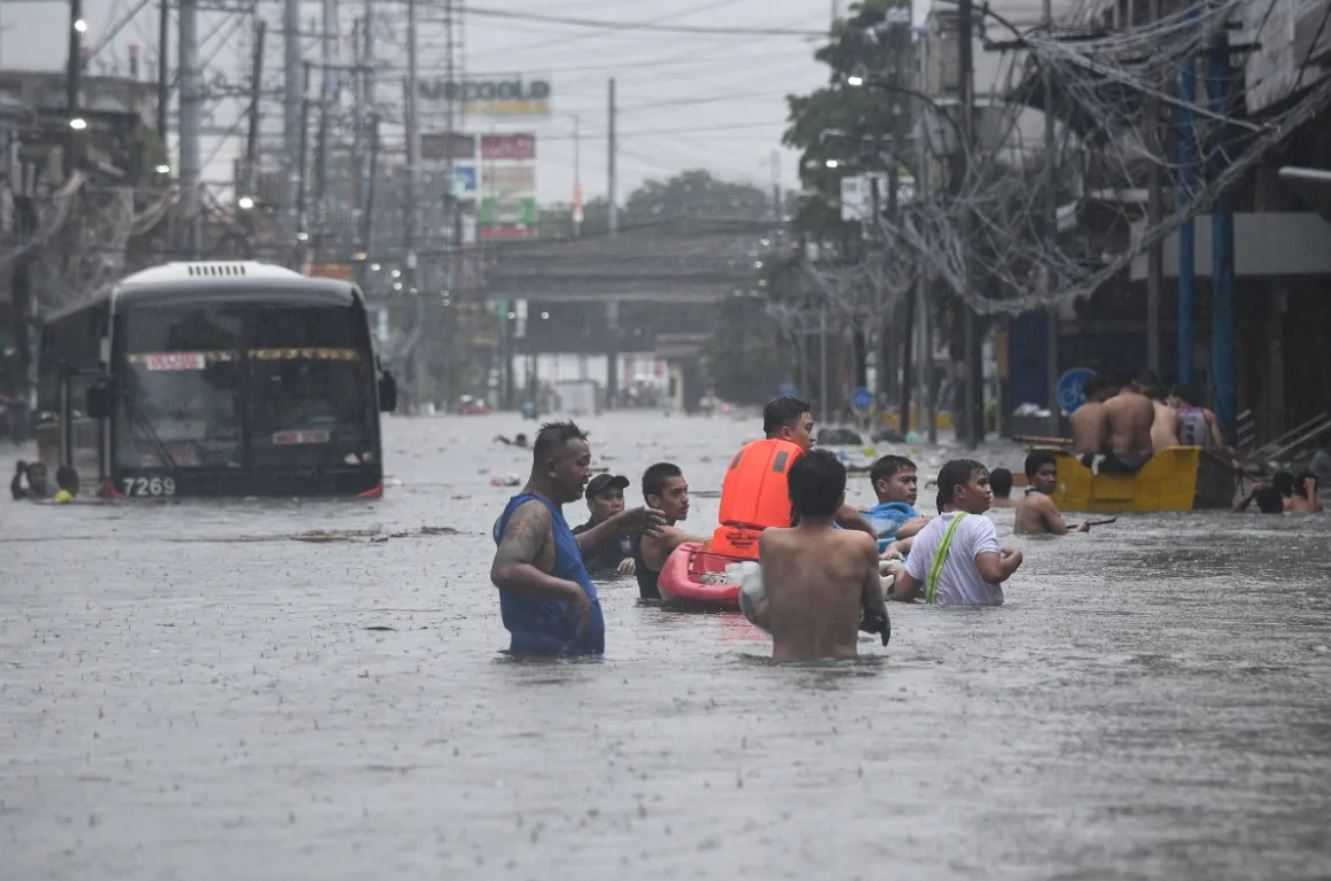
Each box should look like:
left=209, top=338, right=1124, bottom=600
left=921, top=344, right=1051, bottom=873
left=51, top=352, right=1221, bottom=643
left=491, top=398, right=1112, bottom=659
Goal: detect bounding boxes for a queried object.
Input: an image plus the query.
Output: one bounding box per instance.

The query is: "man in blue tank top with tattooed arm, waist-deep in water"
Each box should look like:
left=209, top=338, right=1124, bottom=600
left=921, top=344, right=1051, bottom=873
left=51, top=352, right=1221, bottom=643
left=490, top=422, right=666, bottom=655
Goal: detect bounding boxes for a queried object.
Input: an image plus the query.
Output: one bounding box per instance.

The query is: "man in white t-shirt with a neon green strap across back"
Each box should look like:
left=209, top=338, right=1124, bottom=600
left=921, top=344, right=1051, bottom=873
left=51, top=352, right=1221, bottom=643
left=892, top=459, right=1021, bottom=606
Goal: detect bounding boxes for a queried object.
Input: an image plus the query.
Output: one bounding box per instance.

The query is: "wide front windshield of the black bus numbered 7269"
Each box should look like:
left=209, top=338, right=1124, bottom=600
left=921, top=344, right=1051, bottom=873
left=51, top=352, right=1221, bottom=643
left=116, top=303, right=377, bottom=470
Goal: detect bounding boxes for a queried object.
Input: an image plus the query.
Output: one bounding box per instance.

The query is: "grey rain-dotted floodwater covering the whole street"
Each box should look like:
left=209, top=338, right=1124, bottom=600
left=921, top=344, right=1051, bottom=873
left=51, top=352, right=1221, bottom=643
left=0, top=413, right=1331, bottom=881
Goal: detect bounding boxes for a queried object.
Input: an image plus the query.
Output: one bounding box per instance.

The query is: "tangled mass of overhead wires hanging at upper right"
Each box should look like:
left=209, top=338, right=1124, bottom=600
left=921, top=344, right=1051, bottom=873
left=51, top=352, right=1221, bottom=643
left=830, top=0, right=1331, bottom=314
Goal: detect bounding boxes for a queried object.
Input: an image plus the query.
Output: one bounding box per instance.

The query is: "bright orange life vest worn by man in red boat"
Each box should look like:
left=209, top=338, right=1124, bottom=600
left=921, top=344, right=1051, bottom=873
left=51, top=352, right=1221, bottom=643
left=708, top=439, right=804, bottom=560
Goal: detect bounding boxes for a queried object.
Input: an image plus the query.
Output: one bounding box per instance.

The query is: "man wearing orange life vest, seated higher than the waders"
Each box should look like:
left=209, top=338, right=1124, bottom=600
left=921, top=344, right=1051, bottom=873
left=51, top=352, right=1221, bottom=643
left=708, top=398, right=877, bottom=560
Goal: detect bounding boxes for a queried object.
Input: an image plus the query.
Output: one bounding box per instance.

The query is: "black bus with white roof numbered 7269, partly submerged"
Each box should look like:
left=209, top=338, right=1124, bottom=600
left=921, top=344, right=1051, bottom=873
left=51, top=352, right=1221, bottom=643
left=37, top=262, right=397, bottom=498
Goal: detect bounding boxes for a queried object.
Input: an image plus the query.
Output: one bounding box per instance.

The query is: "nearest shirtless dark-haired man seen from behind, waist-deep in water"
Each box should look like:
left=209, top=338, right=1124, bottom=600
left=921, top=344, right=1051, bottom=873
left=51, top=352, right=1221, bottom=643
left=755, top=450, right=890, bottom=660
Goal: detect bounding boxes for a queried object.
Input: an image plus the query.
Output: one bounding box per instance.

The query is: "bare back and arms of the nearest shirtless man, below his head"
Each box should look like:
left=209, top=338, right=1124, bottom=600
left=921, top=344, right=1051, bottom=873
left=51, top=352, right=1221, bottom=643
left=759, top=520, right=886, bottom=660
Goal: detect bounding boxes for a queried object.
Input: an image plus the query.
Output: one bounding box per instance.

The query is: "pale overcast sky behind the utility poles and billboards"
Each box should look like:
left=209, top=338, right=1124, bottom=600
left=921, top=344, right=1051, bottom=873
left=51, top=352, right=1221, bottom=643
left=0, top=0, right=1071, bottom=202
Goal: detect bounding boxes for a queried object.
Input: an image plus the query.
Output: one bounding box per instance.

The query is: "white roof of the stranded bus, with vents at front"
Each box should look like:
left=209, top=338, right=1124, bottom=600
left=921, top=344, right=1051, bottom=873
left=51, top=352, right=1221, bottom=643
left=47, top=261, right=361, bottom=321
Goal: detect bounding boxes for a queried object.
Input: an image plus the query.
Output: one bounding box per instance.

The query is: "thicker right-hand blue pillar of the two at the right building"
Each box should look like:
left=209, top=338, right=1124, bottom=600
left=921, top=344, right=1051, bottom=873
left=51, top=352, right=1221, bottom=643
left=1209, top=31, right=1238, bottom=442
